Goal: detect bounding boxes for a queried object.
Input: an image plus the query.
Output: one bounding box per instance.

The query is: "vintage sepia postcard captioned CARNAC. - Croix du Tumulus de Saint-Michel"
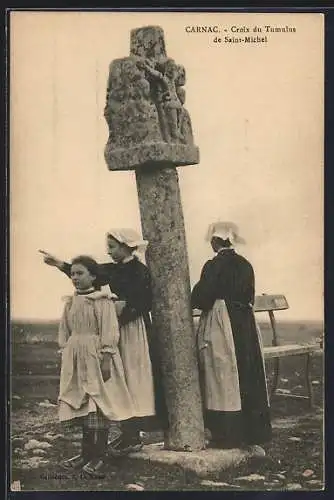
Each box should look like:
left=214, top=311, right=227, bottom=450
left=8, top=10, right=325, bottom=491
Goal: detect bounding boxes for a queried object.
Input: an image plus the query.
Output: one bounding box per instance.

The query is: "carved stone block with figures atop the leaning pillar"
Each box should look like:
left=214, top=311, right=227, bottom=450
left=104, top=26, right=199, bottom=170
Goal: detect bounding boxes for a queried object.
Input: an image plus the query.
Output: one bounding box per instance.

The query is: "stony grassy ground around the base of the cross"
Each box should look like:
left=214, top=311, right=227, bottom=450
left=11, top=320, right=324, bottom=491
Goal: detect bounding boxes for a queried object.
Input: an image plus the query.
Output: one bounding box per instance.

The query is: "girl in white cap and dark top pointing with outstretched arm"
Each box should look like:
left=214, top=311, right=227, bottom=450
left=39, top=229, right=168, bottom=454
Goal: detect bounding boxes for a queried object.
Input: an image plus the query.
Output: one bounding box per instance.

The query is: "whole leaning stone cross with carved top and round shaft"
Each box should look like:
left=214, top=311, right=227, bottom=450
left=104, top=26, right=204, bottom=451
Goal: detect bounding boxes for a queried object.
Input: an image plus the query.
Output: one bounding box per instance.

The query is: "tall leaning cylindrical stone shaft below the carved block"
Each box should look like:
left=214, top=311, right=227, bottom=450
left=136, top=165, right=204, bottom=450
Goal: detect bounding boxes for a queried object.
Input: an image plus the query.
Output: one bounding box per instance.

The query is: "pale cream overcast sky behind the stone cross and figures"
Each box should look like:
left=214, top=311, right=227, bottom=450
left=10, top=12, right=324, bottom=320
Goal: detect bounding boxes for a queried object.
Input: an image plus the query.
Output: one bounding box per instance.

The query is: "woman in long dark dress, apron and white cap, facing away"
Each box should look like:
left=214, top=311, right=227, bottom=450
left=191, top=222, right=271, bottom=453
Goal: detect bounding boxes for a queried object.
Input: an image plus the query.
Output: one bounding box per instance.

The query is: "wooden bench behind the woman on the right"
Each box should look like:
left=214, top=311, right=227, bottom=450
left=193, top=294, right=322, bottom=407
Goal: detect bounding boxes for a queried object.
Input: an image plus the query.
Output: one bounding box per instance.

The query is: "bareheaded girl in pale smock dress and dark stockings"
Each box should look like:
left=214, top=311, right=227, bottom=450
left=58, top=256, right=134, bottom=477
